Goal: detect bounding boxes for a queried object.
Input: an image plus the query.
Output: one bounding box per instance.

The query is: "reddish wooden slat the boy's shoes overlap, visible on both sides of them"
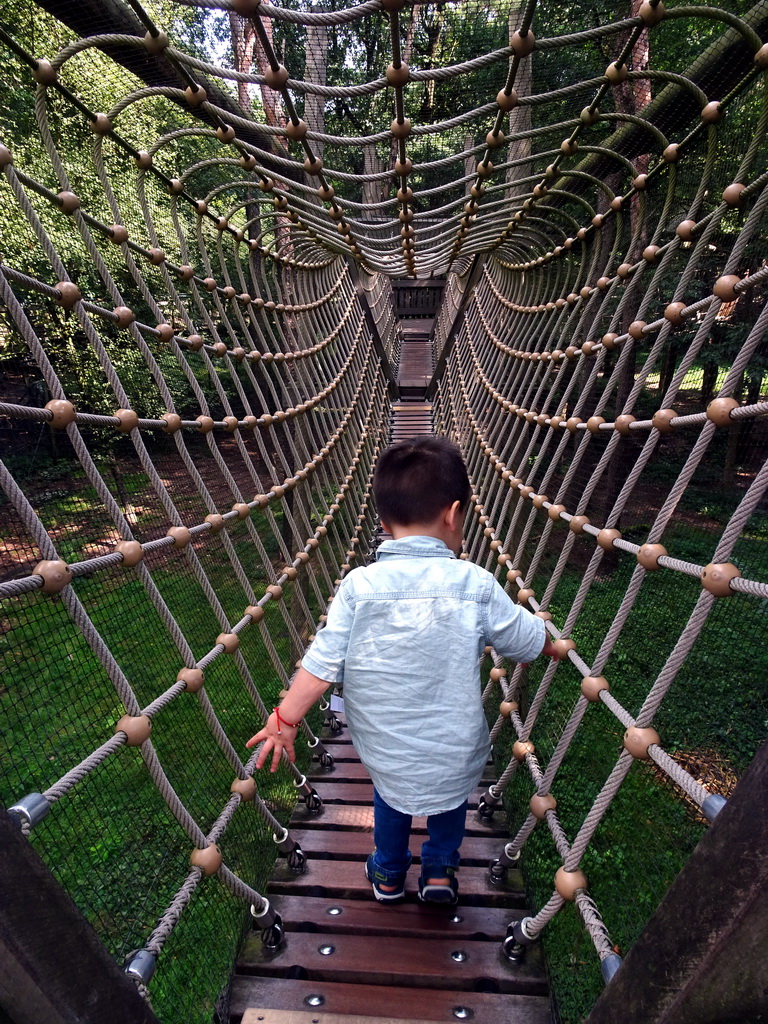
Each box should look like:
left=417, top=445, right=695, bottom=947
left=268, top=859, right=525, bottom=907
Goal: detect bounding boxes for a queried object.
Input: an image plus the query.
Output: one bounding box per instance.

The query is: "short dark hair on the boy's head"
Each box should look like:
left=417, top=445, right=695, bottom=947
left=374, top=434, right=471, bottom=526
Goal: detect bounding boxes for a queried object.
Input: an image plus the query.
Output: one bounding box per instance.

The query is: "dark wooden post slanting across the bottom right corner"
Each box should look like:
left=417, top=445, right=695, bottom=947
left=587, top=743, right=768, bottom=1024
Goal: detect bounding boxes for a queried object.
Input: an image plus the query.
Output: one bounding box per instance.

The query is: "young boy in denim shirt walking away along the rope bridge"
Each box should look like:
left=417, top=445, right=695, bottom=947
left=247, top=435, right=553, bottom=903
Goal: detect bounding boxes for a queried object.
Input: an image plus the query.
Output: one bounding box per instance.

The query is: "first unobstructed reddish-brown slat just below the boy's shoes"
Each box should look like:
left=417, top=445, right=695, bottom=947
left=270, top=895, right=520, bottom=941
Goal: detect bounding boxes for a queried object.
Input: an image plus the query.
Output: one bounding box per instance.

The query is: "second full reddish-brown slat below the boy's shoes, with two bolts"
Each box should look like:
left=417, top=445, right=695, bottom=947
left=240, top=932, right=546, bottom=995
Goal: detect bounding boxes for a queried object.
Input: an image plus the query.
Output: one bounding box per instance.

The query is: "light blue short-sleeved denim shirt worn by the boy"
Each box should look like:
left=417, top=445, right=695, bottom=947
left=302, top=537, right=545, bottom=815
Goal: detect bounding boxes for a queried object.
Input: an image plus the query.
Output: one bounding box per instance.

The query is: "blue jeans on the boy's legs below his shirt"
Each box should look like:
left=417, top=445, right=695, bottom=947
left=373, top=788, right=467, bottom=885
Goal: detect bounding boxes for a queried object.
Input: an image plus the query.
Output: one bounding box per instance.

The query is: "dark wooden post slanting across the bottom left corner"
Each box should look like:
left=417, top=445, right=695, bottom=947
left=0, top=808, right=158, bottom=1024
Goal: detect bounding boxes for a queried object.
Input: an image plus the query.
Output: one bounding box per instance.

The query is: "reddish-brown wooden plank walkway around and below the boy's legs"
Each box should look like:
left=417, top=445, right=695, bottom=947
left=230, top=731, right=551, bottom=1024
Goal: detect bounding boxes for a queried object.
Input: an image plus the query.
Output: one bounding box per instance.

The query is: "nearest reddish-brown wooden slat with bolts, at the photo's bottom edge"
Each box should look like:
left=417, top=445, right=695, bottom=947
left=231, top=977, right=551, bottom=1024
